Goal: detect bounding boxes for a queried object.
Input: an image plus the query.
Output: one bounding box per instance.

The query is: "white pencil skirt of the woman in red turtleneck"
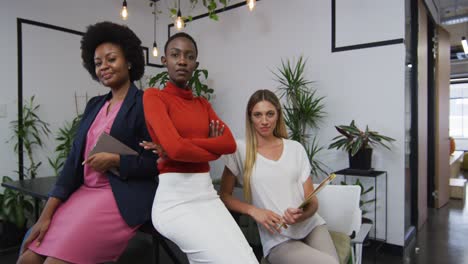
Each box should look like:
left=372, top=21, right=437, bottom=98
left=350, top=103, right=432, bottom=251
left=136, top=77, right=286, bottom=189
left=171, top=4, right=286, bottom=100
left=151, top=173, right=258, bottom=264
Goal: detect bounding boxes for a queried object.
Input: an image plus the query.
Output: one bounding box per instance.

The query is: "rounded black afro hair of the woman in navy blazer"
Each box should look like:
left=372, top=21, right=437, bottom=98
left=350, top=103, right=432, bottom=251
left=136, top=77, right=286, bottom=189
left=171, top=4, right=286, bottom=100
left=81, top=21, right=145, bottom=82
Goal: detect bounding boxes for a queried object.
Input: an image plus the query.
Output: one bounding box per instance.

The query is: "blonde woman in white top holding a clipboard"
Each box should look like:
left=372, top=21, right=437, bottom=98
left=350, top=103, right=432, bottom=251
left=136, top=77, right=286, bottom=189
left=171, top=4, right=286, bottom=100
left=221, top=90, right=338, bottom=264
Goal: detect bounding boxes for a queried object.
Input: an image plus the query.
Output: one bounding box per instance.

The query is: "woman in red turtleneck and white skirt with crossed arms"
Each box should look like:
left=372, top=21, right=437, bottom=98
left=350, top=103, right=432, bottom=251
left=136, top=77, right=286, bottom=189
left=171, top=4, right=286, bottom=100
left=143, top=33, right=258, bottom=264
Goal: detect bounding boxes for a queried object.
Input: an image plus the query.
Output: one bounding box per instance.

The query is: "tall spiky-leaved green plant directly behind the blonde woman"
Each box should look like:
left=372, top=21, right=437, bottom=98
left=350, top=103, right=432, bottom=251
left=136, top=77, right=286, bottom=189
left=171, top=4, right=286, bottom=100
left=273, top=56, right=327, bottom=176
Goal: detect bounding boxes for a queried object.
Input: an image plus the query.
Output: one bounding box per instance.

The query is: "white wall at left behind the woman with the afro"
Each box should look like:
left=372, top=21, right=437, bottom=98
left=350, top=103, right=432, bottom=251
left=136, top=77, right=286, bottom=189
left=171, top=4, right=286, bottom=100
left=0, top=0, right=167, bottom=178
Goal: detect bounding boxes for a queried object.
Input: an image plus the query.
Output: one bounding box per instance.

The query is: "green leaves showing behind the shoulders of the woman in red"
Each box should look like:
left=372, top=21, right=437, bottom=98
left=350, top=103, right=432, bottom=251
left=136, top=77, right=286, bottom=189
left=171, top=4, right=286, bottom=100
left=148, top=69, right=214, bottom=101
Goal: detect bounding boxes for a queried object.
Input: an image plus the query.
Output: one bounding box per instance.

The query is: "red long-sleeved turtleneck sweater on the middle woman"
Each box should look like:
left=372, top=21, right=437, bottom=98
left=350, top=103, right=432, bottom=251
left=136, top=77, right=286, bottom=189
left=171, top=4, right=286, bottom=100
left=143, top=81, right=236, bottom=173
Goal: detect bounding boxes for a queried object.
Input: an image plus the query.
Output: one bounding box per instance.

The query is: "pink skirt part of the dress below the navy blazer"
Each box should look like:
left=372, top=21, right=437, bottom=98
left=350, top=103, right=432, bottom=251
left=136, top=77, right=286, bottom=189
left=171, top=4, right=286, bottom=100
left=29, top=185, right=138, bottom=263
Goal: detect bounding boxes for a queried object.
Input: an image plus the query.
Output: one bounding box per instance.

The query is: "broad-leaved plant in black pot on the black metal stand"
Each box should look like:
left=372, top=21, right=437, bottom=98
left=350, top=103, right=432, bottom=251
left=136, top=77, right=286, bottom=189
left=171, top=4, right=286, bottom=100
left=328, top=120, right=395, bottom=170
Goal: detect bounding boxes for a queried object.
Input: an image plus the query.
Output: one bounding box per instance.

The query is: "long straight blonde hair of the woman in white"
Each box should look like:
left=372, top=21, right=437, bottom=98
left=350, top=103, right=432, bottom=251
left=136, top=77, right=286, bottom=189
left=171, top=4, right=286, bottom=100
left=243, top=89, right=288, bottom=203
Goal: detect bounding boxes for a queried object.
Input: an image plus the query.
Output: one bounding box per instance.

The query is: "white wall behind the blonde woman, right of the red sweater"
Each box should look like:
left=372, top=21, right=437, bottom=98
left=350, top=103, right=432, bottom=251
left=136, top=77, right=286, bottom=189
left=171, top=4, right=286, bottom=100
left=163, top=0, right=405, bottom=245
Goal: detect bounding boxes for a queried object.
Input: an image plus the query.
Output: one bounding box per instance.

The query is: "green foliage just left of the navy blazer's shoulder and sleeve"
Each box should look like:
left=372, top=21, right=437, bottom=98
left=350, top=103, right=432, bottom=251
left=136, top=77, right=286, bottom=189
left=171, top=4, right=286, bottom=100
left=48, top=115, right=81, bottom=175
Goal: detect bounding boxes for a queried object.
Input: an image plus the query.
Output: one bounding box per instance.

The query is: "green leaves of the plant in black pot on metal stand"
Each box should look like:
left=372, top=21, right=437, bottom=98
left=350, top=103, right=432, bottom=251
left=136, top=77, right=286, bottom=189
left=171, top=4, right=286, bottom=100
left=328, top=120, right=395, bottom=156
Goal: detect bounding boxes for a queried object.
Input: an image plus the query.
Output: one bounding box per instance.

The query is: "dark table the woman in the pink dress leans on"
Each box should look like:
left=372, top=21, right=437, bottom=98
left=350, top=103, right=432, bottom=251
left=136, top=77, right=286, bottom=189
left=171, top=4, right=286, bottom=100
left=2, top=176, right=180, bottom=264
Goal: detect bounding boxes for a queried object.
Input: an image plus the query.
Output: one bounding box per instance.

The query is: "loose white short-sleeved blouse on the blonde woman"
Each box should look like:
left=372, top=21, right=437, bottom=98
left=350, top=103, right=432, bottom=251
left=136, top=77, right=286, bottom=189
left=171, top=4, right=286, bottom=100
left=223, top=139, right=325, bottom=256
